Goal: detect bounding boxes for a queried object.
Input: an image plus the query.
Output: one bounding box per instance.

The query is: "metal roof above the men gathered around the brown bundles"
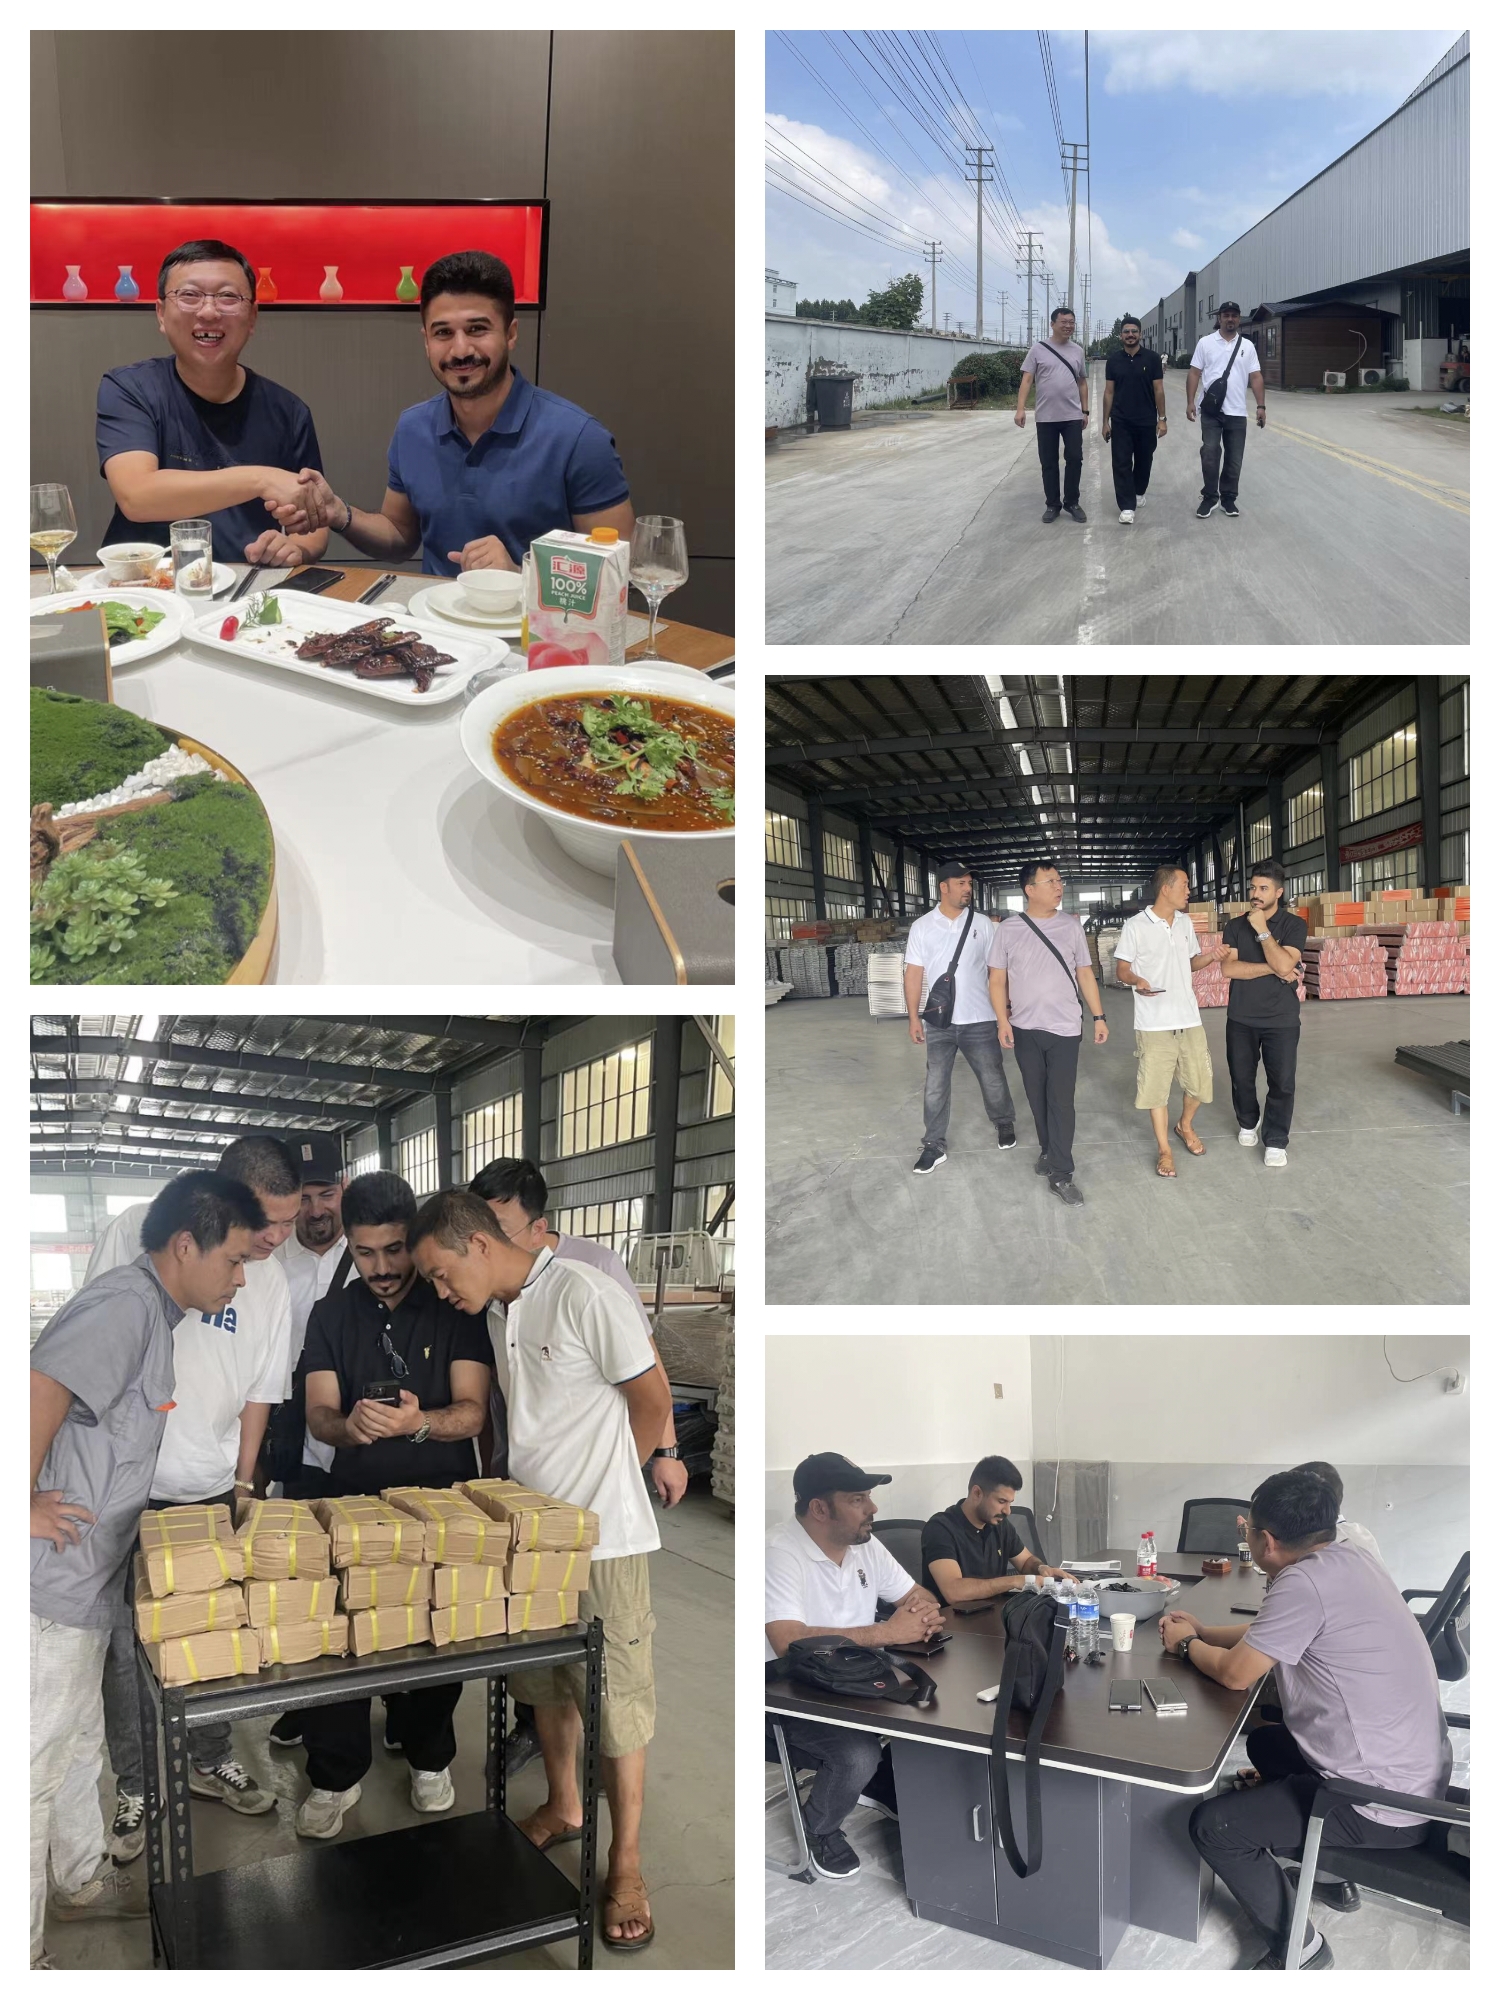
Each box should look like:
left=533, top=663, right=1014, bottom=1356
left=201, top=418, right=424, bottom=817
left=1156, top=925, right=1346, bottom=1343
left=30, top=1014, right=576, bottom=1174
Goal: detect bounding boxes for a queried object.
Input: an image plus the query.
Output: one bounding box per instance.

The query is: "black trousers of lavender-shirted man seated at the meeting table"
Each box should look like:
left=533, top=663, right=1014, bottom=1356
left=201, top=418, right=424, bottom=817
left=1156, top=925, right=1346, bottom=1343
left=1188, top=1722, right=1428, bottom=1952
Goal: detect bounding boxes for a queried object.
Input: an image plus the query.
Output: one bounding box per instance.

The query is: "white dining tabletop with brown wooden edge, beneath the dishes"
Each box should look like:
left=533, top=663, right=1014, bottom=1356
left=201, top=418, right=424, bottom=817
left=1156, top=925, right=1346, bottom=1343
left=32, top=562, right=734, bottom=986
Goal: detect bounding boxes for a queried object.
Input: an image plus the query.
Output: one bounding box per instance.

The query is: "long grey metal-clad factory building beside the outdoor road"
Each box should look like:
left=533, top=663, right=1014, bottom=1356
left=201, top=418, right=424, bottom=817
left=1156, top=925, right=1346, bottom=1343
left=1142, top=34, right=1470, bottom=390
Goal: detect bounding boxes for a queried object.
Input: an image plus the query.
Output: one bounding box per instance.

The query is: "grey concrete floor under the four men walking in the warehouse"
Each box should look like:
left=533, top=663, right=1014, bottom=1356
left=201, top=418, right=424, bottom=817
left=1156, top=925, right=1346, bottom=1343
left=766, top=988, right=1468, bottom=1306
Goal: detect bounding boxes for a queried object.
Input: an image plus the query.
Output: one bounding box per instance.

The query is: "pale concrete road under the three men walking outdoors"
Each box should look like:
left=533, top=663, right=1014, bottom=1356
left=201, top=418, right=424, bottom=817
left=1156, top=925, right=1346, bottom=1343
left=766, top=364, right=1468, bottom=646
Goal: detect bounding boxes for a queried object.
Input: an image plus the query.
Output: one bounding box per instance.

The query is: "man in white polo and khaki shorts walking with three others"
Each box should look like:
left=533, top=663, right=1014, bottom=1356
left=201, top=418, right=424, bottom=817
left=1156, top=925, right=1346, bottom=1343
left=1114, top=868, right=1224, bottom=1180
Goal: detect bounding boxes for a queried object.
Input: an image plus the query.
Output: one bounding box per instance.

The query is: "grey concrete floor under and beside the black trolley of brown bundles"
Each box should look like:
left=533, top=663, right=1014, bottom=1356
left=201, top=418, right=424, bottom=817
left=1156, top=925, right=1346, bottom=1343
left=48, top=1480, right=734, bottom=1972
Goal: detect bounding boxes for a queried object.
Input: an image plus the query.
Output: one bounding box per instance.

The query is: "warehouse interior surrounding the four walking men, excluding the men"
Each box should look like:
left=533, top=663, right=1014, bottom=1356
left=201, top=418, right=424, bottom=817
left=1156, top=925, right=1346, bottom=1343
left=766, top=674, right=1470, bottom=1304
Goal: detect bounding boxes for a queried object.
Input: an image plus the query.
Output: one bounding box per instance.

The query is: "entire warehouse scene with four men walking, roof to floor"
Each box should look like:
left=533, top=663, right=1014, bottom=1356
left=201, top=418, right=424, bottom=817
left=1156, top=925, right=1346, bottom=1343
left=766, top=674, right=1470, bottom=1306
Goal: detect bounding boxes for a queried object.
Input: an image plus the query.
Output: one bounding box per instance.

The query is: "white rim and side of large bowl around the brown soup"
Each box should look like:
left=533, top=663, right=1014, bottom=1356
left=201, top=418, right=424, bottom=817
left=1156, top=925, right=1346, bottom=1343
left=458, top=662, right=734, bottom=880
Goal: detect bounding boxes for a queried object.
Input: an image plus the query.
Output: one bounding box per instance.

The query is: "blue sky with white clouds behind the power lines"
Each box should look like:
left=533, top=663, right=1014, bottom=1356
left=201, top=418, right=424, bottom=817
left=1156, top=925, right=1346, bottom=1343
left=764, top=28, right=1460, bottom=334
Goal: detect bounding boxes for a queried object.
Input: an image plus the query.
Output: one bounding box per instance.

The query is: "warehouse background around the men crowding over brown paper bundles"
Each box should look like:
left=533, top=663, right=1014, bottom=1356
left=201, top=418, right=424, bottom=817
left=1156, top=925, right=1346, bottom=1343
left=30, top=1014, right=734, bottom=1970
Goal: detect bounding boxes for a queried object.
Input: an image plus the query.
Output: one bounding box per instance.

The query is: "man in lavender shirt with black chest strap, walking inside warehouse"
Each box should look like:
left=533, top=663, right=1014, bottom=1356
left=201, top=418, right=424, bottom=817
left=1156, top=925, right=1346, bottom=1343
left=990, top=862, right=1110, bottom=1208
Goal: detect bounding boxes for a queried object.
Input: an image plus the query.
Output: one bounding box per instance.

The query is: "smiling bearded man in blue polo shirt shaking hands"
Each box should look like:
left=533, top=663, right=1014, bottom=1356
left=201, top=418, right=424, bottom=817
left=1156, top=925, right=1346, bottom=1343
left=276, top=250, right=636, bottom=576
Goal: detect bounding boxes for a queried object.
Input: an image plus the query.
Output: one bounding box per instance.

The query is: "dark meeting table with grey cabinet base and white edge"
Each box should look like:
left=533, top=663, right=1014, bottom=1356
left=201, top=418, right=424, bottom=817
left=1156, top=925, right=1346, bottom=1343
left=766, top=1548, right=1266, bottom=1970
